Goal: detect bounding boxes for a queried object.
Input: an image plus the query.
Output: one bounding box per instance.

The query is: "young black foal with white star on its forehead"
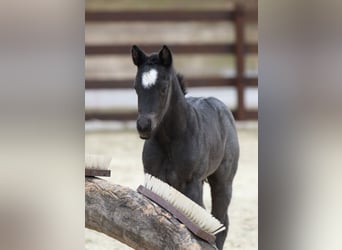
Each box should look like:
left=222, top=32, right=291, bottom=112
left=132, top=46, right=239, bottom=249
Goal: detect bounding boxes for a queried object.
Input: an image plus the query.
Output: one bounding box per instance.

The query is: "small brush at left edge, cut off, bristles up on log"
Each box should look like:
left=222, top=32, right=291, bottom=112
left=85, top=155, right=112, bottom=177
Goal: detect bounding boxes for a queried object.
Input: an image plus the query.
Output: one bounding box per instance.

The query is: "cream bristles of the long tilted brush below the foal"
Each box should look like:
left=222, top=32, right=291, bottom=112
left=145, top=174, right=226, bottom=234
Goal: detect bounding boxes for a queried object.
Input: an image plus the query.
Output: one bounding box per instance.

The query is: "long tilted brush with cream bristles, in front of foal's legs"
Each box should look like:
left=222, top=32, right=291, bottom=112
left=138, top=174, right=226, bottom=243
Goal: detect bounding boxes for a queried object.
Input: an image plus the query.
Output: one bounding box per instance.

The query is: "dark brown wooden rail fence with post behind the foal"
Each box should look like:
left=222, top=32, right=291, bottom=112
left=85, top=5, right=258, bottom=120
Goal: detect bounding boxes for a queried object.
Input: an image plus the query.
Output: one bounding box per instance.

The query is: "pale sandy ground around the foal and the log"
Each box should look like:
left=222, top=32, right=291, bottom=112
left=85, top=126, right=258, bottom=250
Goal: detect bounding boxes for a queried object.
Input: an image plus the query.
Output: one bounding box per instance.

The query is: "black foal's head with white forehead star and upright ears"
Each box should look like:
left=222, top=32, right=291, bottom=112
left=132, top=45, right=174, bottom=139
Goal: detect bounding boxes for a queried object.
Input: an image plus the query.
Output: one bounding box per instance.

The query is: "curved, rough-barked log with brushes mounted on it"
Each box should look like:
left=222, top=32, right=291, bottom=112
left=85, top=177, right=217, bottom=250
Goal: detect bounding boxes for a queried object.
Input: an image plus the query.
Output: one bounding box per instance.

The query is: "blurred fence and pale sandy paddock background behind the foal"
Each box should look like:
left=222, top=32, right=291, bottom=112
left=85, top=0, right=258, bottom=250
